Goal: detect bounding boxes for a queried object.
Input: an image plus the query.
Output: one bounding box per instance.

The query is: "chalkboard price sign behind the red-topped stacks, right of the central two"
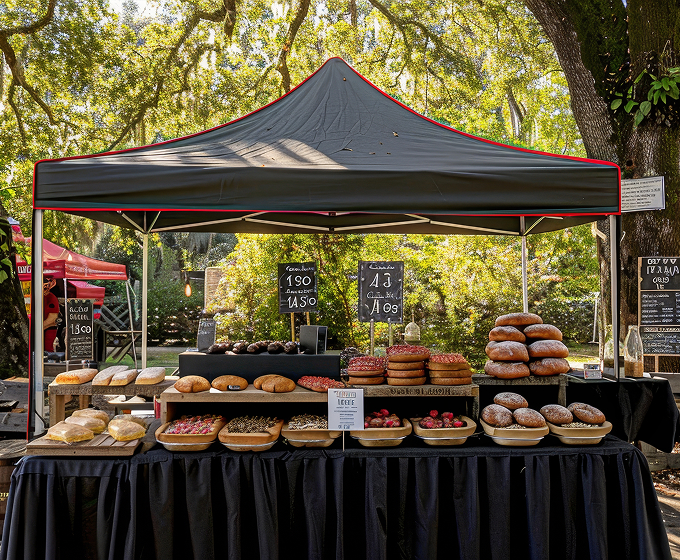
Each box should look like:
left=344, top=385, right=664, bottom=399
left=359, top=261, right=404, bottom=323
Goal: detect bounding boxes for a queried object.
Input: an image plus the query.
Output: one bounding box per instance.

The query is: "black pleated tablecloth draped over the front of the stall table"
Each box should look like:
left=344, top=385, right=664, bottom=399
left=0, top=436, right=670, bottom=560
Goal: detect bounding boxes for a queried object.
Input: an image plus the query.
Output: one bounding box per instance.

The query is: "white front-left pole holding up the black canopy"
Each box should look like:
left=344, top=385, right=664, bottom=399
left=31, top=210, right=45, bottom=434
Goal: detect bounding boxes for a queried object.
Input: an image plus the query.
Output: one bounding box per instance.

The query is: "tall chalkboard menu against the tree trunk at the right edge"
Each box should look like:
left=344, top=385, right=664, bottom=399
left=638, top=257, right=680, bottom=356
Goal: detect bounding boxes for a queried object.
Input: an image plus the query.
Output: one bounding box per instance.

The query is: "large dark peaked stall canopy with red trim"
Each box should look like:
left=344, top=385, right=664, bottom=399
left=34, top=58, right=620, bottom=234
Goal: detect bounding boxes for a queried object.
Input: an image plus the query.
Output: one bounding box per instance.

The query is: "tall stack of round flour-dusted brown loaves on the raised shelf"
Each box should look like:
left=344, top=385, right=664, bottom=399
left=484, top=313, right=570, bottom=379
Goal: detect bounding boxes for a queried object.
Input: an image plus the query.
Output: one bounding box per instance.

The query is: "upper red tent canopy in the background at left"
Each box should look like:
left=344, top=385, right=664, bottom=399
left=17, top=237, right=127, bottom=282
